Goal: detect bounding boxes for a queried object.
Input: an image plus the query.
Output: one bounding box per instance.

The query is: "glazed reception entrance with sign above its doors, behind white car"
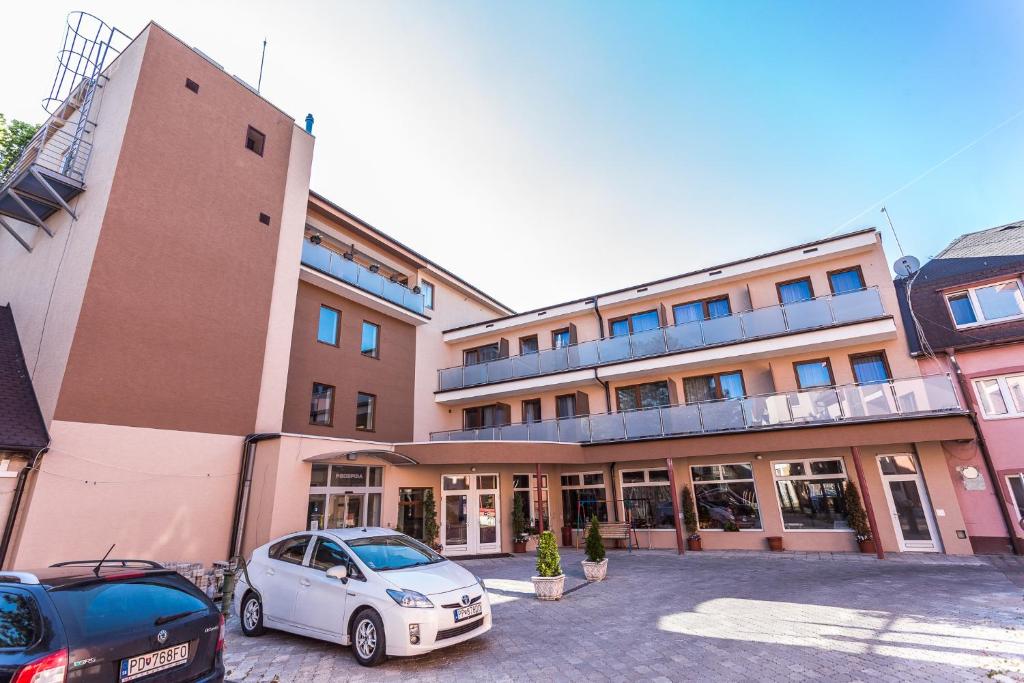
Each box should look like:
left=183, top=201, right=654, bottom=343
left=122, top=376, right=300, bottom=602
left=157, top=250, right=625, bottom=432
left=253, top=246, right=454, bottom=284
left=306, top=464, right=384, bottom=530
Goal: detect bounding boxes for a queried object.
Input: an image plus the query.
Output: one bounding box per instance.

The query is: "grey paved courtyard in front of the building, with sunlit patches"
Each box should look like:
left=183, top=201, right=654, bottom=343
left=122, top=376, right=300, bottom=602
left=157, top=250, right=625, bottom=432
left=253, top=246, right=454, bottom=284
left=226, top=551, right=1024, bottom=683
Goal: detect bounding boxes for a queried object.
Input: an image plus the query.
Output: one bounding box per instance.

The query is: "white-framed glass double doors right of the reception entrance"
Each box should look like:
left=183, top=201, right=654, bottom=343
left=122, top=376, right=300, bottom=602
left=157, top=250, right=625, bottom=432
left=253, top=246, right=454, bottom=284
left=441, top=474, right=502, bottom=556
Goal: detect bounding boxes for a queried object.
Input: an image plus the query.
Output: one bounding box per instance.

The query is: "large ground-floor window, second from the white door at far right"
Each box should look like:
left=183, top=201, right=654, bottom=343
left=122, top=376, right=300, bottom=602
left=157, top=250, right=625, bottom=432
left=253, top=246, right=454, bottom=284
left=690, top=463, right=761, bottom=529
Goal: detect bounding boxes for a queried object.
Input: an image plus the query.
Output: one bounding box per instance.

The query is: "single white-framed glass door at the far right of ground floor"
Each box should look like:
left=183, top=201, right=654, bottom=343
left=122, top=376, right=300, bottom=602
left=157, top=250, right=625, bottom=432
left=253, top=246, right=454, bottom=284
left=879, top=453, right=942, bottom=552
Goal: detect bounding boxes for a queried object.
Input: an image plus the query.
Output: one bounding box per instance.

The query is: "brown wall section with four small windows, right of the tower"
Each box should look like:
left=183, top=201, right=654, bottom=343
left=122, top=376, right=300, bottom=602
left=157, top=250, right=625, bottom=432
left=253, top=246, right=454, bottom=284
left=284, top=282, right=416, bottom=441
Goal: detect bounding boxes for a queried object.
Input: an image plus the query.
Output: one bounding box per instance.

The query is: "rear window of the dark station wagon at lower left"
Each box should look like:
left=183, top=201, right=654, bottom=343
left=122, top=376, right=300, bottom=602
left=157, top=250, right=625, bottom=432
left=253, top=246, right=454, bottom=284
left=50, top=577, right=210, bottom=641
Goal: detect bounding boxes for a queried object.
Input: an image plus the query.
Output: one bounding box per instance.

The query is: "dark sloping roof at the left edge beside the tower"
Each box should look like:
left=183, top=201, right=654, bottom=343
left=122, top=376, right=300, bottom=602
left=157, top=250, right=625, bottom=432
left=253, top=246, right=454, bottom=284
left=0, top=305, right=49, bottom=451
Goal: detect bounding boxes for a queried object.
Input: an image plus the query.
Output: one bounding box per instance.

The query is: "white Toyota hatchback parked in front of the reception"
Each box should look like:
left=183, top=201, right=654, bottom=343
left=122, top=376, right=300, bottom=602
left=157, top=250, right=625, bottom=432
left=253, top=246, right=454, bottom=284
left=234, top=527, right=490, bottom=667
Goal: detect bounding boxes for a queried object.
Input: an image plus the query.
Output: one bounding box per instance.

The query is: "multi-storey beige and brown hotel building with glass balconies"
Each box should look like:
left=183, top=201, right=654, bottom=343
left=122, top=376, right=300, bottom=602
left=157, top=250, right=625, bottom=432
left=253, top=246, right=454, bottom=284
left=0, top=17, right=991, bottom=565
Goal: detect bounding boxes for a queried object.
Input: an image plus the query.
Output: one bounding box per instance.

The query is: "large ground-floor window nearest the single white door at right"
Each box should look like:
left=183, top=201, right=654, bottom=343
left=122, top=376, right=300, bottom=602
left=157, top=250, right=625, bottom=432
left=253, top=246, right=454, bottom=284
left=772, top=460, right=850, bottom=531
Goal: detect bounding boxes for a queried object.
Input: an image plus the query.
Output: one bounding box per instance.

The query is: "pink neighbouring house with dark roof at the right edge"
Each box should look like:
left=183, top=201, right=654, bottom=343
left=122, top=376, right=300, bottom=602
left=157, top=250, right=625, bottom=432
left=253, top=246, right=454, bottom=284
left=896, top=221, right=1024, bottom=553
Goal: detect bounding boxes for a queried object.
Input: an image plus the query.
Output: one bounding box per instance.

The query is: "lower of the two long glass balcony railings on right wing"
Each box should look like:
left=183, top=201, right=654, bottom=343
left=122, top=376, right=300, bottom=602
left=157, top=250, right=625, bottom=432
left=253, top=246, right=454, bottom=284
left=430, top=375, right=963, bottom=443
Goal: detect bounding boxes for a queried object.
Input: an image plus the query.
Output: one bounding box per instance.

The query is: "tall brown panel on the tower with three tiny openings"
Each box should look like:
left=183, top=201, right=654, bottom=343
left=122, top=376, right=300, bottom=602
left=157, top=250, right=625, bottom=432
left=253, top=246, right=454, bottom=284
left=55, top=26, right=294, bottom=434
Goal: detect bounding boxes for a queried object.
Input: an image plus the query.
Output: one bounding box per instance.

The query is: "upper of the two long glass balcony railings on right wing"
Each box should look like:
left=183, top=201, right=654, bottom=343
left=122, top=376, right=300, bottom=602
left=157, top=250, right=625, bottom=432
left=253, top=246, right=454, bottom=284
left=437, top=287, right=886, bottom=391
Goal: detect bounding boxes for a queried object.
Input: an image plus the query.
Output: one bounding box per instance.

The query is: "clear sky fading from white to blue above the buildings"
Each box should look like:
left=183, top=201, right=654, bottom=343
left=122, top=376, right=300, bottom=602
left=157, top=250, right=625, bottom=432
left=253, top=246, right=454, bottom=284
left=8, top=0, right=1024, bottom=309
